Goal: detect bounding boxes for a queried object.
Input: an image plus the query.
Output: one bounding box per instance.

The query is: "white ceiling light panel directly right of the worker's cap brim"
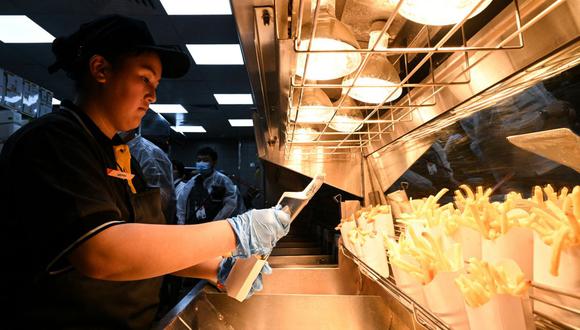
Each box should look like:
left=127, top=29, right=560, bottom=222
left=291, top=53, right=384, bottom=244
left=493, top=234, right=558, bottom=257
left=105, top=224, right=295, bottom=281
left=186, top=44, right=244, bottom=65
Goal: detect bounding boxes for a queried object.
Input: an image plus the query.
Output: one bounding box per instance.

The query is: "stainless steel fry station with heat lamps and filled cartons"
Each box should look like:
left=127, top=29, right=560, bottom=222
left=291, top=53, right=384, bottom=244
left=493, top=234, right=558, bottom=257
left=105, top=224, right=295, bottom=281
left=156, top=0, right=580, bottom=329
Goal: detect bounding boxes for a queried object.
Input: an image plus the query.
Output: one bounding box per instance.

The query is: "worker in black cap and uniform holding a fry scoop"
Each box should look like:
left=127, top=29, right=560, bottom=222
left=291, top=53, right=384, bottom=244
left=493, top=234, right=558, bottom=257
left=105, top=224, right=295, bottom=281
left=0, top=15, right=290, bottom=329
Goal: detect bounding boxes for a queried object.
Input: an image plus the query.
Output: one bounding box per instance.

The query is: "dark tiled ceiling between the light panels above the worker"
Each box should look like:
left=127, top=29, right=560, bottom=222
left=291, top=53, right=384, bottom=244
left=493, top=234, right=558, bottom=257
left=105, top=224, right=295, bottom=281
left=0, top=0, right=254, bottom=139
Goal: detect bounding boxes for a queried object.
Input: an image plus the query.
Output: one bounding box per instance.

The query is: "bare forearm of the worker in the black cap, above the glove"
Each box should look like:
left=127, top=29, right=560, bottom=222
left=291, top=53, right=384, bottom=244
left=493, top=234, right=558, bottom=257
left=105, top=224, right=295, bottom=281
left=69, top=221, right=236, bottom=281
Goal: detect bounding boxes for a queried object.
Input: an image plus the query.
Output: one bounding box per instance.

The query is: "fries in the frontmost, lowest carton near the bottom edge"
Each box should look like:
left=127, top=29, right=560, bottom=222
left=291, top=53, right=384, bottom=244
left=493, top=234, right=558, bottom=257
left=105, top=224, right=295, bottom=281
left=455, top=258, right=531, bottom=307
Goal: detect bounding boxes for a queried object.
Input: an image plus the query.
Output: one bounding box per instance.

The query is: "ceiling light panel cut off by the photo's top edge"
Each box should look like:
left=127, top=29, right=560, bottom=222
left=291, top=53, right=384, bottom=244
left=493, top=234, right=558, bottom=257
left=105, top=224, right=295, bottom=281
left=161, top=0, right=232, bottom=15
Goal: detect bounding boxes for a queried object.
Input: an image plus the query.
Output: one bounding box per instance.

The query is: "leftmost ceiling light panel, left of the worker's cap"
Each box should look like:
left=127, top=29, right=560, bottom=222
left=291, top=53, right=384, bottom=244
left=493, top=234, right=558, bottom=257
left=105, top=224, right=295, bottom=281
left=0, top=15, right=54, bottom=44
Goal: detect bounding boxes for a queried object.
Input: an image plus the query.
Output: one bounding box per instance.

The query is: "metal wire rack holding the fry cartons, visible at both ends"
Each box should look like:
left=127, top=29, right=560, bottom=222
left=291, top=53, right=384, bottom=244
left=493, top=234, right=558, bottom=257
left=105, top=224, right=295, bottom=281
left=339, top=240, right=580, bottom=330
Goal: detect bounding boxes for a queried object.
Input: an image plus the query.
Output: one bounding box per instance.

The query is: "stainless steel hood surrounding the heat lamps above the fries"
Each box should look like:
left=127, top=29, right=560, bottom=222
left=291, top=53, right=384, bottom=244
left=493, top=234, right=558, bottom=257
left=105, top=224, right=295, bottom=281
left=232, top=0, right=580, bottom=197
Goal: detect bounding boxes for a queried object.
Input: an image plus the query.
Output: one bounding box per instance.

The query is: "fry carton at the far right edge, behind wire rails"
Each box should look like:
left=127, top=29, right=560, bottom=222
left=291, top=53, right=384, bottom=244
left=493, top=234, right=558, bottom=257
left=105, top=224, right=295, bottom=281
left=524, top=186, right=580, bottom=328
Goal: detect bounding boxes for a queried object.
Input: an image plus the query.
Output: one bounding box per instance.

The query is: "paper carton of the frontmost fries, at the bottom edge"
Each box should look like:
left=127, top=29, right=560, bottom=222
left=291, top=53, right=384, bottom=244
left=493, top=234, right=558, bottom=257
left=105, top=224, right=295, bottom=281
left=465, top=294, right=533, bottom=330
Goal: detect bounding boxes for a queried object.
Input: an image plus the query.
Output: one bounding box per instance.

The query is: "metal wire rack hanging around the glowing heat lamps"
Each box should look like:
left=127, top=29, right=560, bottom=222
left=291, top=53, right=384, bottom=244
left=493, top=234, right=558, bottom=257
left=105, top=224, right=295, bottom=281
left=285, top=0, right=565, bottom=159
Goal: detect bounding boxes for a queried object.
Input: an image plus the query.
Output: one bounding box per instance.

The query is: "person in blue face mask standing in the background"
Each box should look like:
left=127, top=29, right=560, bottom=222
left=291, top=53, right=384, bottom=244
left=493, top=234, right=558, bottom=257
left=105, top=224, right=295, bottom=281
left=177, top=147, right=241, bottom=224
